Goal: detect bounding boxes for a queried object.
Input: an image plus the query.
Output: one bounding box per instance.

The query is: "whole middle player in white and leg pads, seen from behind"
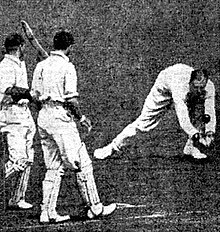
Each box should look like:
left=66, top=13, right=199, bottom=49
left=32, top=31, right=116, bottom=223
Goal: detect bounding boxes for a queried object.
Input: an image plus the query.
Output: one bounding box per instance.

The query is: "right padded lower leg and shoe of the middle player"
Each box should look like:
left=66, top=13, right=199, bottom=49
left=76, top=143, right=116, bottom=219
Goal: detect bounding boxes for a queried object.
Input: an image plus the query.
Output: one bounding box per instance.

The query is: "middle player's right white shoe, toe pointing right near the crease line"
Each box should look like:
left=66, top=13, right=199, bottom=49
left=87, top=203, right=117, bottom=219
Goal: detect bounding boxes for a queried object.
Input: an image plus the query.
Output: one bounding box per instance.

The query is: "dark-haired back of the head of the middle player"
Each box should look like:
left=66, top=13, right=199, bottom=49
left=53, top=30, right=74, bottom=50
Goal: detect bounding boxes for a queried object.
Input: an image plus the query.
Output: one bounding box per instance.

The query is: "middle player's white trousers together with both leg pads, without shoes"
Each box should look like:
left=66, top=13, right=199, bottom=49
left=38, top=104, right=100, bottom=217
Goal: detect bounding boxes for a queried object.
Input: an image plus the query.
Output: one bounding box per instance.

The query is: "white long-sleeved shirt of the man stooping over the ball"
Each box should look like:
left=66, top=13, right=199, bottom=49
left=147, top=64, right=216, bottom=136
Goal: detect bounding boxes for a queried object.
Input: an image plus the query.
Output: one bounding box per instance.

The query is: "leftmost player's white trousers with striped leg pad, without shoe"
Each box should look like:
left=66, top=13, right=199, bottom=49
left=1, top=105, right=36, bottom=203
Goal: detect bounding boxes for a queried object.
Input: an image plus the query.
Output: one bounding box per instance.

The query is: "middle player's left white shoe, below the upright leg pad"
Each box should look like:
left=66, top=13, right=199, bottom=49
left=40, top=211, right=70, bottom=224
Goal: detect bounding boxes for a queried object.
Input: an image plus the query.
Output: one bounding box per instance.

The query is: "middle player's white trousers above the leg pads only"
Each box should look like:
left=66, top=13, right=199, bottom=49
left=38, top=105, right=82, bottom=170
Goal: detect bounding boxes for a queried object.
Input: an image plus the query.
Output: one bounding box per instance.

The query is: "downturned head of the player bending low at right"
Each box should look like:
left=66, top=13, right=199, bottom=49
left=190, top=69, right=208, bottom=92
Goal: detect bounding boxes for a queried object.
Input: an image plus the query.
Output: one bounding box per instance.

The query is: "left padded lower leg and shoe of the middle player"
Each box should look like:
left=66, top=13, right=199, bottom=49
left=40, top=168, right=70, bottom=223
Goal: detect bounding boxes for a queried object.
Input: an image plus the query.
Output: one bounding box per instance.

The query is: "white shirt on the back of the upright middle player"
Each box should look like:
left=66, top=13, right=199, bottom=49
left=31, top=51, right=78, bottom=102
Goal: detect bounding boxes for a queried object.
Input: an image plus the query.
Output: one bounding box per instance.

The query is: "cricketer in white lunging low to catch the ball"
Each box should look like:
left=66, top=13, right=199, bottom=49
left=94, top=64, right=216, bottom=159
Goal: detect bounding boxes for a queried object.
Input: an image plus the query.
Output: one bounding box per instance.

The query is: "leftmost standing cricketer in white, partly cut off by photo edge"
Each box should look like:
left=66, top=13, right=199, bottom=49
left=0, top=33, right=36, bottom=209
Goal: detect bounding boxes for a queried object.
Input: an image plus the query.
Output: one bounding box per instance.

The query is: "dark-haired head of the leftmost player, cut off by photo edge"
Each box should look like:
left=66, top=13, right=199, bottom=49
left=4, top=33, right=25, bottom=54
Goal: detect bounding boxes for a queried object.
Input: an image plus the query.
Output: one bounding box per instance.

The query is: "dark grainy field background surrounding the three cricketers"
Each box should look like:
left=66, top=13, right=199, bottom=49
left=0, top=0, right=220, bottom=231
